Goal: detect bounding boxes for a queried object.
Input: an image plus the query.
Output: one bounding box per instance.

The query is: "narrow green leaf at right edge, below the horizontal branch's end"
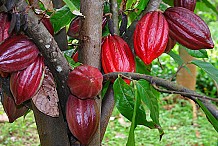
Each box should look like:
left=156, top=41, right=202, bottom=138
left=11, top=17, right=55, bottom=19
left=196, top=100, right=218, bottom=132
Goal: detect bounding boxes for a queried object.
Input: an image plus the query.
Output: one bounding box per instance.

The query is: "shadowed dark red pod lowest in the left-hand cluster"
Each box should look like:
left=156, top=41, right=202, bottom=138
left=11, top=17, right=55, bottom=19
left=2, top=92, right=28, bottom=123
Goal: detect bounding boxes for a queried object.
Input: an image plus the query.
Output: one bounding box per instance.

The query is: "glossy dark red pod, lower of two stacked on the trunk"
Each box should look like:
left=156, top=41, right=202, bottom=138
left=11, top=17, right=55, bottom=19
left=66, top=95, right=99, bottom=145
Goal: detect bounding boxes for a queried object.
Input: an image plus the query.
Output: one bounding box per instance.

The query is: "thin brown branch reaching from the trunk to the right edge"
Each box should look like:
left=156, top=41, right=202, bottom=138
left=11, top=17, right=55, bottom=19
left=104, top=72, right=218, bottom=119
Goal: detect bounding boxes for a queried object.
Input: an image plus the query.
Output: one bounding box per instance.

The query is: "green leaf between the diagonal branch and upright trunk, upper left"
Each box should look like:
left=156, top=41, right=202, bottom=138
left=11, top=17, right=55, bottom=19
left=50, top=6, right=74, bottom=33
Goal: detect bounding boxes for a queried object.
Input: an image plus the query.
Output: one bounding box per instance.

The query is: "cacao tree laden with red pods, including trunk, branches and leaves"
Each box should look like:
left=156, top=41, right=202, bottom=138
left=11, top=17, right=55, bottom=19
left=0, top=0, right=218, bottom=146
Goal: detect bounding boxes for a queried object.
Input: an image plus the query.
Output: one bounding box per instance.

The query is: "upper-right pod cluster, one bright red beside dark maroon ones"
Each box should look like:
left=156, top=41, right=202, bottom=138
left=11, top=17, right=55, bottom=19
left=134, top=0, right=214, bottom=65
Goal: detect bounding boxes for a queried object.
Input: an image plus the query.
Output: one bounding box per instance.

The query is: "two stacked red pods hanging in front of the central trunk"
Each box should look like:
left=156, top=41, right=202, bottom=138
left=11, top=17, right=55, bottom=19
left=66, top=65, right=103, bottom=145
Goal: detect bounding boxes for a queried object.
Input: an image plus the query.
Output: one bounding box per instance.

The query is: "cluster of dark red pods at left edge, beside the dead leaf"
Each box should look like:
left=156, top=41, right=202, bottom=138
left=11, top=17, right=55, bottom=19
left=0, top=13, right=53, bottom=122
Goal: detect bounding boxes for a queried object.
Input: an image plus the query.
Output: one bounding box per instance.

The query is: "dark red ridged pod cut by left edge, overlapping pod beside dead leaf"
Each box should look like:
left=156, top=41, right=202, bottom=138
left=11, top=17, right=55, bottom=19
left=0, top=35, right=39, bottom=72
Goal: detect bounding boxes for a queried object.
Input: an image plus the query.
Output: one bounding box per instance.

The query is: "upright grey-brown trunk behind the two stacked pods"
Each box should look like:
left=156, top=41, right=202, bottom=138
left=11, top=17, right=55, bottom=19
left=79, top=0, right=103, bottom=146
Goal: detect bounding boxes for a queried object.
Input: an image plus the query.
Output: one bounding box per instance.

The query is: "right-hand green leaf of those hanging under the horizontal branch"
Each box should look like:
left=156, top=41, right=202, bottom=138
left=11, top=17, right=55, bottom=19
left=136, top=80, right=160, bottom=126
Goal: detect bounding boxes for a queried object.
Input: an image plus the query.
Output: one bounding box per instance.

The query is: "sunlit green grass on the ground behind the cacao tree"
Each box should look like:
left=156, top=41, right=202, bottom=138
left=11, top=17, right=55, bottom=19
left=0, top=100, right=218, bottom=146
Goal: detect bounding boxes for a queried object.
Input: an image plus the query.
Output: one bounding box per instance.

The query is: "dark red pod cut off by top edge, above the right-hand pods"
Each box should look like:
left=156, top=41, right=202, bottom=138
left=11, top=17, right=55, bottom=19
left=174, top=0, right=196, bottom=11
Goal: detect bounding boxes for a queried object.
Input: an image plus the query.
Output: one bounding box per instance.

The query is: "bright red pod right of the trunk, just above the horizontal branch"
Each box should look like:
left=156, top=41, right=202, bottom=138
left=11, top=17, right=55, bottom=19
left=101, top=35, right=135, bottom=73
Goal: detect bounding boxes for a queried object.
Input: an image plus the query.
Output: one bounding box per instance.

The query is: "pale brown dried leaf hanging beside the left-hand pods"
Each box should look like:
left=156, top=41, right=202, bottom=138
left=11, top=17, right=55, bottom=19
left=32, top=68, right=59, bottom=117
